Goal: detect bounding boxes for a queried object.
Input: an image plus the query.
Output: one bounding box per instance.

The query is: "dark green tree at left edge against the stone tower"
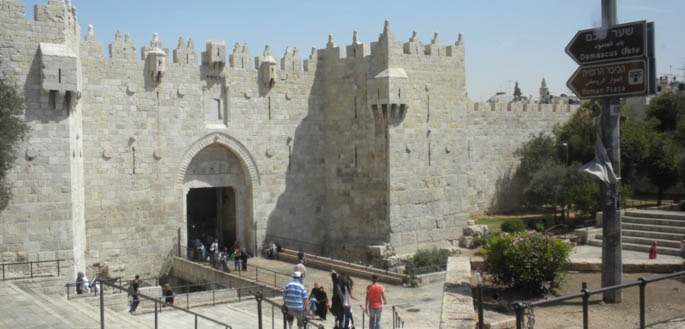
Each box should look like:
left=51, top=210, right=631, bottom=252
left=0, top=78, right=29, bottom=211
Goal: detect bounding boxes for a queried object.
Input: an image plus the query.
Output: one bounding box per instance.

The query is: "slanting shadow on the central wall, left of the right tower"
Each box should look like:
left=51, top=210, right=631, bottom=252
left=259, top=66, right=328, bottom=254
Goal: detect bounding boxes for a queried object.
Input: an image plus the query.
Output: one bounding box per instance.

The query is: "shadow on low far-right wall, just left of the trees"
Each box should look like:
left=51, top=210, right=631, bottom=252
left=487, top=166, right=527, bottom=214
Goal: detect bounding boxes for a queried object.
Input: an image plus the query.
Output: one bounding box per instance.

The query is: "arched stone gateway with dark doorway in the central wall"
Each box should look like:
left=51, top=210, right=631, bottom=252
left=178, top=133, right=260, bottom=252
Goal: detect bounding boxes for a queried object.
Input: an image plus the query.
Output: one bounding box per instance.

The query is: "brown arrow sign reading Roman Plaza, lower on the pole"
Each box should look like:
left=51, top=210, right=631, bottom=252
left=566, top=59, right=650, bottom=98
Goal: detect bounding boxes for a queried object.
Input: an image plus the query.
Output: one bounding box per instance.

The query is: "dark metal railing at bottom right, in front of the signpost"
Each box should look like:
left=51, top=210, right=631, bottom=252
left=510, top=271, right=685, bottom=329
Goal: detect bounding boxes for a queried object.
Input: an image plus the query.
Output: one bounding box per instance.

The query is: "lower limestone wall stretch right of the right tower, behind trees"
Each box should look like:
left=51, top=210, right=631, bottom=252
left=464, top=103, right=578, bottom=215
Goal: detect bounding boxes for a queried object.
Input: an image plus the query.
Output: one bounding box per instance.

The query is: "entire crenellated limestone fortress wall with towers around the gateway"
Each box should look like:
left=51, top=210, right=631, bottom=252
left=0, top=0, right=574, bottom=276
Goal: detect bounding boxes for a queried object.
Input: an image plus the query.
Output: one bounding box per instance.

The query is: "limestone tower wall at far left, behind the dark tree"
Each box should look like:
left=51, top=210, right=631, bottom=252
left=0, top=0, right=85, bottom=276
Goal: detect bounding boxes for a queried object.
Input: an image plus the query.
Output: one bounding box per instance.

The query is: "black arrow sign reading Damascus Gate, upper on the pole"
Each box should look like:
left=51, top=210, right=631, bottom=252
left=566, top=21, right=647, bottom=65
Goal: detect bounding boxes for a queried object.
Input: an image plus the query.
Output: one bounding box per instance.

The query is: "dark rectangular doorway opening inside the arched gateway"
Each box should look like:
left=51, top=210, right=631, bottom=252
left=186, top=187, right=237, bottom=248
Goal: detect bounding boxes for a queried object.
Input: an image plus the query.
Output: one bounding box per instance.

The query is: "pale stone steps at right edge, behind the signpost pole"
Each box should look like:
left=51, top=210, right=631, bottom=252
left=589, top=209, right=685, bottom=256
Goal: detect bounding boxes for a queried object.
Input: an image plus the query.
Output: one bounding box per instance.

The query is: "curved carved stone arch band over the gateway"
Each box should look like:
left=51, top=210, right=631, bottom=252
left=178, top=133, right=261, bottom=186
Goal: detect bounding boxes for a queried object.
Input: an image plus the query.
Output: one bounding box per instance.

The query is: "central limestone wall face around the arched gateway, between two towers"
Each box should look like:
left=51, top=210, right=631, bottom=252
left=75, top=31, right=324, bottom=273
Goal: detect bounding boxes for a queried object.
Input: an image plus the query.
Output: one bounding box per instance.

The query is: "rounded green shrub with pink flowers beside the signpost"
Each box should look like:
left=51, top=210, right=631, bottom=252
left=481, top=231, right=571, bottom=293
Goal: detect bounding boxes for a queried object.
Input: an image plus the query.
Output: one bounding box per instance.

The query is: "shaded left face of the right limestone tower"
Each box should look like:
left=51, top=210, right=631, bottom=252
left=319, top=39, right=388, bottom=259
